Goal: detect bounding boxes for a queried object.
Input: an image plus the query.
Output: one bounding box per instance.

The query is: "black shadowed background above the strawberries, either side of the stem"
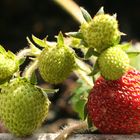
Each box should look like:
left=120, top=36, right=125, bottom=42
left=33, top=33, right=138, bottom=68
left=0, top=0, right=140, bottom=52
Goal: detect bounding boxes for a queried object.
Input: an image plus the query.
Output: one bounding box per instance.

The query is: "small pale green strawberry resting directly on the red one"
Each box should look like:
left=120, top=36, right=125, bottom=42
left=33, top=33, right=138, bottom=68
left=98, top=46, right=130, bottom=80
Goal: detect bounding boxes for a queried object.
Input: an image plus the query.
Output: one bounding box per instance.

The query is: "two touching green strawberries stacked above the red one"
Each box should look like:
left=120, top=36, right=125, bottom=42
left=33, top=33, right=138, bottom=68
left=80, top=7, right=130, bottom=80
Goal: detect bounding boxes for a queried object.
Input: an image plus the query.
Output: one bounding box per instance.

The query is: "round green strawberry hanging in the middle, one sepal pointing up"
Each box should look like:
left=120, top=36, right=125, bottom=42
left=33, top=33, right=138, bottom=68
left=38, top=32, right=75, bottom=84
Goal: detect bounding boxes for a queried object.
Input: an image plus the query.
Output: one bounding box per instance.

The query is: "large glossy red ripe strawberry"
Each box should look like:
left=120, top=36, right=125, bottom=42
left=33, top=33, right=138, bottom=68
left=87, top=69, right=140, bottom=134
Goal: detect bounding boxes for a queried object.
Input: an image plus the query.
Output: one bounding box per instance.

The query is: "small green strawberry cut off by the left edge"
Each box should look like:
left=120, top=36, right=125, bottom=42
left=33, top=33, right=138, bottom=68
left=0, top=46, right=19, bottom=83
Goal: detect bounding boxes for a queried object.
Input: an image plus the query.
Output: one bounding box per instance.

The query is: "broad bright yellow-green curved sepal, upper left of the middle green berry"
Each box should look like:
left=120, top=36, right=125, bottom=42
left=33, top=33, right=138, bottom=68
left=32, top=35, right=48, bottom=47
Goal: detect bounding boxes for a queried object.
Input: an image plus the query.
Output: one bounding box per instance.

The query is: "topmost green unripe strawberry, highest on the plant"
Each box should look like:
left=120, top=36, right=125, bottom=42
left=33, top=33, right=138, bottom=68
left=80, top=14, right=121, bottom=52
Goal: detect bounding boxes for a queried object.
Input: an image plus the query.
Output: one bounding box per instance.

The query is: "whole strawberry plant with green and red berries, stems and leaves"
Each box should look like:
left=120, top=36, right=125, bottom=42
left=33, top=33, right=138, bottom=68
left=0, top=0, right=140, bottom=139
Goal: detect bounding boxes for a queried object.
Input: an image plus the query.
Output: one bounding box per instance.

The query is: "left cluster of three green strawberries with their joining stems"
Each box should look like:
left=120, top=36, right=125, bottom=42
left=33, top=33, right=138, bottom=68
left=0, top=32, right=77, bottom=137
